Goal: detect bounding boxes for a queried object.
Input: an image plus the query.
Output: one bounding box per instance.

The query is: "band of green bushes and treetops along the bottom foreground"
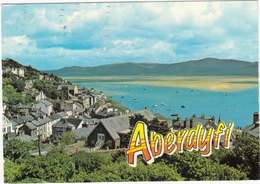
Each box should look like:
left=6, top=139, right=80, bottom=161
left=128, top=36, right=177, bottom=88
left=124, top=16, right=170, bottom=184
left=4, top=137, right=259, bottom=183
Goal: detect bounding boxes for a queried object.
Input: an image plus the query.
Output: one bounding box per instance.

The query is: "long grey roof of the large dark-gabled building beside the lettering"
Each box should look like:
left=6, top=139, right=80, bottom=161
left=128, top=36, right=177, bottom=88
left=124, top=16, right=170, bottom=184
left=101, top=109, right=155, bottom=140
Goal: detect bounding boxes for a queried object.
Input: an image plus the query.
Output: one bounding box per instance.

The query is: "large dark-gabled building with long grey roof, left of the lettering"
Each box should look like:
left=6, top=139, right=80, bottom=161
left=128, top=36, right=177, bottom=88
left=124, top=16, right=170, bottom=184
left=88, top=109, right=155, bottom=149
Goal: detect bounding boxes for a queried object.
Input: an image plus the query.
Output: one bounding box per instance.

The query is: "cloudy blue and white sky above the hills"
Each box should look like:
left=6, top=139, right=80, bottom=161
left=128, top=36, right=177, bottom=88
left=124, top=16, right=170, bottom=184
left=2, top=1, right=258, bottom=70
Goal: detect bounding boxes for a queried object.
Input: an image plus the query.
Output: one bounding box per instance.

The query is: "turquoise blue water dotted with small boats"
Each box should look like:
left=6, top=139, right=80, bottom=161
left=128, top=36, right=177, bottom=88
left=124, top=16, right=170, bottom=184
left=69, top=79, right=259, bottom=128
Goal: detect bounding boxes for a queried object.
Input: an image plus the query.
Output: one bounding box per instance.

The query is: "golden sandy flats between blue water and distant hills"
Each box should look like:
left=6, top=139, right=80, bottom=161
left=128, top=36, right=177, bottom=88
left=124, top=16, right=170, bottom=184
left=63, top=76, right=258, bottom=91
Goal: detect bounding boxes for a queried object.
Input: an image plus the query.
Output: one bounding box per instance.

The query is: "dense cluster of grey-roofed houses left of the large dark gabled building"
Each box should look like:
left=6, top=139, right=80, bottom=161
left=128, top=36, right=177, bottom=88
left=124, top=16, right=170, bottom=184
left=2, top=80, right=135, bottom=148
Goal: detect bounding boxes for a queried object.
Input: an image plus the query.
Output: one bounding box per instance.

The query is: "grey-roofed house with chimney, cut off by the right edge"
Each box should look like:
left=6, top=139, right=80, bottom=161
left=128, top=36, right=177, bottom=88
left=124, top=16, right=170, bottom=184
left=242, top=112, right=259, bottom=140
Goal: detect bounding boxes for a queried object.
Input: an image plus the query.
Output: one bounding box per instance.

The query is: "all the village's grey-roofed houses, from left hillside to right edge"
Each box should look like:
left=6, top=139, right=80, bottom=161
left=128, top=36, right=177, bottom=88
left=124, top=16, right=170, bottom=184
left=2, top=64, right=259, bottom=149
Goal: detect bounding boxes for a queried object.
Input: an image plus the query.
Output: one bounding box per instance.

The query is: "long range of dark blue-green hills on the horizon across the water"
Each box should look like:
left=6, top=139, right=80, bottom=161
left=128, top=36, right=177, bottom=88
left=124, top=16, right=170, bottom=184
left=44, top=58, right=258, bottom=76
